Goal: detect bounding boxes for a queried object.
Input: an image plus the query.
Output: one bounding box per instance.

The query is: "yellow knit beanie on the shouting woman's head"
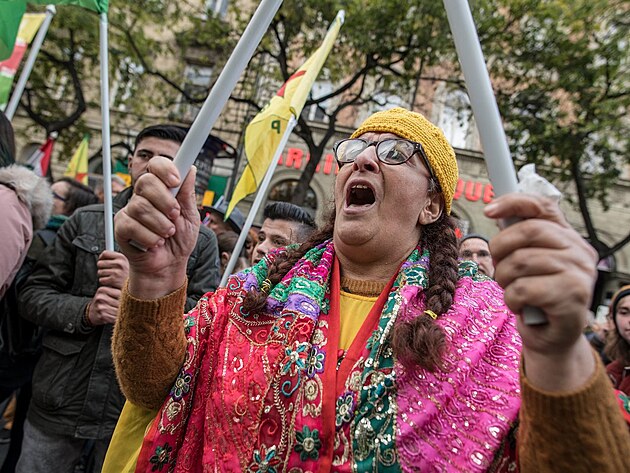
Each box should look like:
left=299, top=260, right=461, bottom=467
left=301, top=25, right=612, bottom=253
left=351, top=107, right=459, bottom=214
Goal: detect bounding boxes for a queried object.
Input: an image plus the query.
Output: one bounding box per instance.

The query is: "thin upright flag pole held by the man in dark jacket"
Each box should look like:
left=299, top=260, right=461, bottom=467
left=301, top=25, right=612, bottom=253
left=99, top=12, right=114, bottom=251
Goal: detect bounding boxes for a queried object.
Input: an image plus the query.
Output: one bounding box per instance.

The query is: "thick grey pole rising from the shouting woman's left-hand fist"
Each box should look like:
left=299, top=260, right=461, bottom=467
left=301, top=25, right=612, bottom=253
left=174, top=0, right=282, bottom=194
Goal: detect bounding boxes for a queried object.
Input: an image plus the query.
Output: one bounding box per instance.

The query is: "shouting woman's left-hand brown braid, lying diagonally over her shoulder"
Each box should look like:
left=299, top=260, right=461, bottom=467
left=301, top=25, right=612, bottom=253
left=243, top=211, right=335, bottom=314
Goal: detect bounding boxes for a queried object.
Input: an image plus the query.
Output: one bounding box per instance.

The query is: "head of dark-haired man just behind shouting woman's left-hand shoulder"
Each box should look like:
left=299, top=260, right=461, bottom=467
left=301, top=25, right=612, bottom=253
left=252, top=202, right=315, bottom=264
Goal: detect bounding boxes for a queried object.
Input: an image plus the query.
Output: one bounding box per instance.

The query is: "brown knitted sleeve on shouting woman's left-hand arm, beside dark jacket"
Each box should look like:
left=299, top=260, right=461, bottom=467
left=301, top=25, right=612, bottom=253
left=112, top=284, right=186, bottom=409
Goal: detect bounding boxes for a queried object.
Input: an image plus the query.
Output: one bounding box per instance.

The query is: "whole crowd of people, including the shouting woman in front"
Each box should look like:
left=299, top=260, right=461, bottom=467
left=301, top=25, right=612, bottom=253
left=0, top=108, right=630, bottom=473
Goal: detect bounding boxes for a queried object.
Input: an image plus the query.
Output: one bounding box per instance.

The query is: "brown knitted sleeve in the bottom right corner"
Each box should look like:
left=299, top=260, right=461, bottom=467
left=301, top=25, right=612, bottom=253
left=518, top=353, right=630, bottom=473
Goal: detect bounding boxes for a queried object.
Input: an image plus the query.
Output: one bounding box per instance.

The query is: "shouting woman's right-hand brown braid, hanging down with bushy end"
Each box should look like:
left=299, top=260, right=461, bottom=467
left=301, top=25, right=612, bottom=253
left=392, top=208, right=458, bottom=371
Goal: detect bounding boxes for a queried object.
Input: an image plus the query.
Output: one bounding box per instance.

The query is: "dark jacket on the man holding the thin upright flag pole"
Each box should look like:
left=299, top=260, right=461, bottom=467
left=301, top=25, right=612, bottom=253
left=19, top=188, right=219, bottom=439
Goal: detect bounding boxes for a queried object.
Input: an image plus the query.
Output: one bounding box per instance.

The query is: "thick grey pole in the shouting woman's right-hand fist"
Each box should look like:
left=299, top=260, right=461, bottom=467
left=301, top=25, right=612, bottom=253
left=444, top=0, right=547, bottom=325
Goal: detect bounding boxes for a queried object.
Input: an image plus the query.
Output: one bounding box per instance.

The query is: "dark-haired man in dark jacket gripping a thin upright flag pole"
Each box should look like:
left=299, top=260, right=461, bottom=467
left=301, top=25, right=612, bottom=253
left=17, top=125, right=219, bottom=473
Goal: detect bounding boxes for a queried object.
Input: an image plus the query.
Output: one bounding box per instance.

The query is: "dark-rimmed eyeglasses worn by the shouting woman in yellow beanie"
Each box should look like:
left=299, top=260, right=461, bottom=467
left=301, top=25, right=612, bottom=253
left=333, top=138, right=434, bottom=177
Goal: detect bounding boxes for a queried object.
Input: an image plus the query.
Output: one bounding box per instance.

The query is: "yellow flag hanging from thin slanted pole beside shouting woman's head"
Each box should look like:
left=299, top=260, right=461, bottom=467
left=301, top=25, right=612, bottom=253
left=225, top=12, right=343, bottom=218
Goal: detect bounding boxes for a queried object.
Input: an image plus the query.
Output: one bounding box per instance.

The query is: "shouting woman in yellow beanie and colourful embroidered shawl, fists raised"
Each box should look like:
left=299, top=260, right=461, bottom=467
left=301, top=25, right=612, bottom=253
left=112, top=108, right=630, bottom=473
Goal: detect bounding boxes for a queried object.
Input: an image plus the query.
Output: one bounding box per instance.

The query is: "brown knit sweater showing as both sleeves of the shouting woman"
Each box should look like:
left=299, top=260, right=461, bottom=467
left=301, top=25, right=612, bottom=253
left=112, top=285, right=630, bottom=473
